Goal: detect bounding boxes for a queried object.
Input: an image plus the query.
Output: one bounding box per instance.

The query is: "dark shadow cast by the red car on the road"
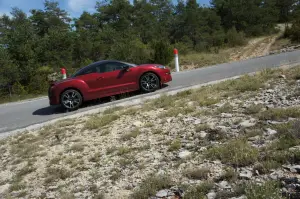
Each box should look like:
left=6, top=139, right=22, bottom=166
left=32, top=85, right=168, bottom=116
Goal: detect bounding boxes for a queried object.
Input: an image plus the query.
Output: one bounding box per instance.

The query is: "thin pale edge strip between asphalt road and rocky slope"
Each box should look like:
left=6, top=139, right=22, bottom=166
left=0, top=63, right=300, bottom=140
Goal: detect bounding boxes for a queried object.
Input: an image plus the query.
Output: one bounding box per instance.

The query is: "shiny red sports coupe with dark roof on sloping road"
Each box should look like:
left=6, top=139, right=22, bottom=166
left=48, top=60, right=172, bottom=111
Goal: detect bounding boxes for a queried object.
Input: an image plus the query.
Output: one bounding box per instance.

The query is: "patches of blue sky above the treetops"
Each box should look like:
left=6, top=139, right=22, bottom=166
left=0, top=0, right=210, bottom=17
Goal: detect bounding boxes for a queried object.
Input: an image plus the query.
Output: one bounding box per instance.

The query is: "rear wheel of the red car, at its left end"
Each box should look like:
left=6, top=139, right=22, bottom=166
left=60, top=89, right=83, bottom=111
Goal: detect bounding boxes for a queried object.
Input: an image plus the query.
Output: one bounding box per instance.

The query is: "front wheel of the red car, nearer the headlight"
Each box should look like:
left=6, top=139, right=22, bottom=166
left=139, top=72, right=160, bottom=93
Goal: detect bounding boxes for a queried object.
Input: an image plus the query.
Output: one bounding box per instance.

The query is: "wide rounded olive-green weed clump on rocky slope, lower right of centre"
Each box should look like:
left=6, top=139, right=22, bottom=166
left=206, top=139, right=259, bottom=166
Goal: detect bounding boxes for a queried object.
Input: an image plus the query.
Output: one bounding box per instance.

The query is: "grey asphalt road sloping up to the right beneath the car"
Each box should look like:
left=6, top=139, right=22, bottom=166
left=0, top=51, right=300, bottom=133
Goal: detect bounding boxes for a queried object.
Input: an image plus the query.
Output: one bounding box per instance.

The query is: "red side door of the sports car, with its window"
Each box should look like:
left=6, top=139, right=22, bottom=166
left=102, top=62, right=138, bottom=95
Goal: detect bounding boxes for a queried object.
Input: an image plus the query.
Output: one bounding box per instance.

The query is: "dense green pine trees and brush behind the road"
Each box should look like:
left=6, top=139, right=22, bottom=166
left=0, top=0, right=300, bottom=101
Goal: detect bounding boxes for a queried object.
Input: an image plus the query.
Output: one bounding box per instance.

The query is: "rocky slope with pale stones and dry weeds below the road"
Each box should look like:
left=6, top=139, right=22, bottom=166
left=0, top=67, right=300, bottom=199
